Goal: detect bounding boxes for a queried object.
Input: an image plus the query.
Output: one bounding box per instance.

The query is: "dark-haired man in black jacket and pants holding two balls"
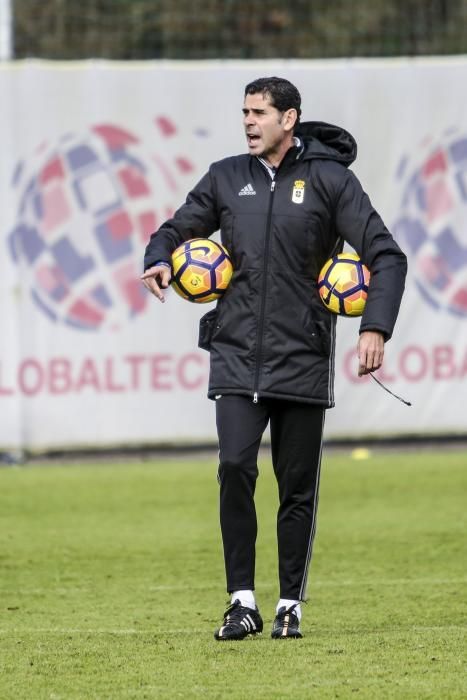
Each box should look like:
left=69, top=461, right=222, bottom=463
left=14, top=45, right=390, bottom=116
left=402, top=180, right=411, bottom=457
left=142, top=78, right=406, bottom=640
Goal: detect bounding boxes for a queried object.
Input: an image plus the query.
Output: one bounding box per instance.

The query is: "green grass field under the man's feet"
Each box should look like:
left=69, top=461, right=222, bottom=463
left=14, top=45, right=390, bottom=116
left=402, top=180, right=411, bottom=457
left=0, top=451, right=467, bottom=700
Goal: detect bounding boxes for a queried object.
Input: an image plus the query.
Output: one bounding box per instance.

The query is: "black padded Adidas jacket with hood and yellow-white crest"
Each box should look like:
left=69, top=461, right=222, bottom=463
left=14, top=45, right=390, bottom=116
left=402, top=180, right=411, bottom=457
left=144, top=122, right=407, bottom=408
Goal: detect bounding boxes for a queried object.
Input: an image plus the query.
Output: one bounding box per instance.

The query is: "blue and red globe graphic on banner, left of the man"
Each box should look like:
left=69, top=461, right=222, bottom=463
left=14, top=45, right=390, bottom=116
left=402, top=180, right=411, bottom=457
left=9, top=118, right=197, bottom=330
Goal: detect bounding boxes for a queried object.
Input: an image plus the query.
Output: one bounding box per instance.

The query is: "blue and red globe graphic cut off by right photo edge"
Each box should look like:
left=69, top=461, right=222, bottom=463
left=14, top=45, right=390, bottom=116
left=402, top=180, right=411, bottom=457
left=393, top=131, right=467, bottom=318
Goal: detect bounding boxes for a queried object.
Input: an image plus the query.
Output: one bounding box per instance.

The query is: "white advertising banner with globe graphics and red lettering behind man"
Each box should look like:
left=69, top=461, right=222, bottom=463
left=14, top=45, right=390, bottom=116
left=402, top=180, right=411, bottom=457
left=0, top=57, right=467, bottom=451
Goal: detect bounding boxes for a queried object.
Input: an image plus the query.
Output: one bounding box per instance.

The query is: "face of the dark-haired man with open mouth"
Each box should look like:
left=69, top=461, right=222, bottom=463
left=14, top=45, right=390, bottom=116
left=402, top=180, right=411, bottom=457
left=243, top=93, right=292, bottom=165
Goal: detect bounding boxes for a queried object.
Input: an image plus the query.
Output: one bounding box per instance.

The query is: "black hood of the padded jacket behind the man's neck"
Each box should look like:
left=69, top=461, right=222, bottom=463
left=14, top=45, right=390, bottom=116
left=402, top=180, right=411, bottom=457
left=294, top=122, right=357, bottom=166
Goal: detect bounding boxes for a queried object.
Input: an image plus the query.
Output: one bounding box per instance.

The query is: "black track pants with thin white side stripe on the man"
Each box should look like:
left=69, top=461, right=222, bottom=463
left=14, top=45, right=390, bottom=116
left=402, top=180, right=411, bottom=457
left=216, top=396, right=324, bottom=600
